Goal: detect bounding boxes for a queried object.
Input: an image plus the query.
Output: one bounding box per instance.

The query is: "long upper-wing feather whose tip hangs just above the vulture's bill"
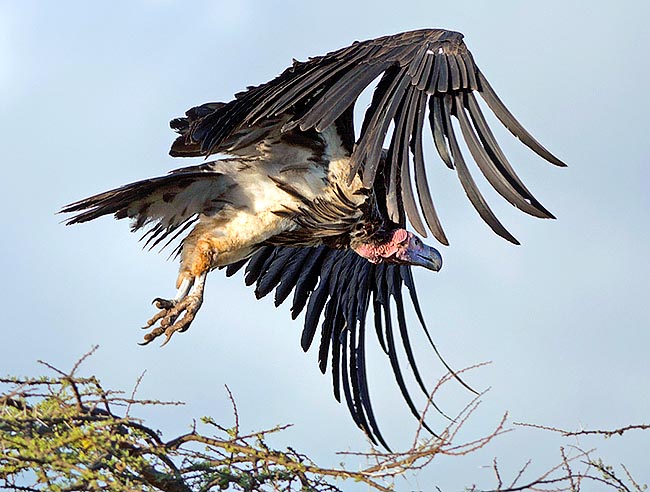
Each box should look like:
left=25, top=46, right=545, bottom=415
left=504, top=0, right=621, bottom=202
left=411, top=92, right=449, bottom=246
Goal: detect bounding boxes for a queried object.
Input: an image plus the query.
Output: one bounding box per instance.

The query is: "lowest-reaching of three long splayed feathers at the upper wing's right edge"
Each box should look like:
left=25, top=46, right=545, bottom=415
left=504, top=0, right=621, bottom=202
left=444, top=96, right=519, bottom=244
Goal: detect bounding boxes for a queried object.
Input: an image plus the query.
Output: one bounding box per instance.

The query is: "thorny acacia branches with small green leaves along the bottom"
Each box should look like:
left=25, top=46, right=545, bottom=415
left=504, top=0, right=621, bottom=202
left=0, top=351, right=648, bottom=492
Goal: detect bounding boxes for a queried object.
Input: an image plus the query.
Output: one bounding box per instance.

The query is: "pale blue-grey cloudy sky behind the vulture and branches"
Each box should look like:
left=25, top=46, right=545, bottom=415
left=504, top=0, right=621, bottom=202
left=0, top=0, right=650, bottom=492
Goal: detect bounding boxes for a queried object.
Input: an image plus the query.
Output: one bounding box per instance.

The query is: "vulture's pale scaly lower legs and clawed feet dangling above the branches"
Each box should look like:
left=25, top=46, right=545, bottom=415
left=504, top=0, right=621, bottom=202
left=141, top=271, right=208, bottom=346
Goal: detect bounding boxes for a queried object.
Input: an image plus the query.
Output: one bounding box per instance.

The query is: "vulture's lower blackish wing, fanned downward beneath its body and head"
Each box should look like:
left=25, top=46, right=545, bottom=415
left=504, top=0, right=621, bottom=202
left=226, top=246, right=460, bottom=448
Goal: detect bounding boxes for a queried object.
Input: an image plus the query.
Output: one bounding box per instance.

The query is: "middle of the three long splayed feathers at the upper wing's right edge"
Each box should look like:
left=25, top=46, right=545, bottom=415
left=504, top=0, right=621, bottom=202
left=454, top=94, right=548, bottom=218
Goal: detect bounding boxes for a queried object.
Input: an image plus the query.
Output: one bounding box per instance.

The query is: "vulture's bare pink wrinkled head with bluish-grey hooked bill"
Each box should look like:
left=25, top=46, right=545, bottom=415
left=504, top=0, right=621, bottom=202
left=352, top=229, right=442, bottom=272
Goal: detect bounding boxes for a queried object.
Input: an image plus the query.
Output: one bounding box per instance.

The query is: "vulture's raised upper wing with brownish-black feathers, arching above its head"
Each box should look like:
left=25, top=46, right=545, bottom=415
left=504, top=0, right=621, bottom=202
left=175, top=29, right=564, bottom=244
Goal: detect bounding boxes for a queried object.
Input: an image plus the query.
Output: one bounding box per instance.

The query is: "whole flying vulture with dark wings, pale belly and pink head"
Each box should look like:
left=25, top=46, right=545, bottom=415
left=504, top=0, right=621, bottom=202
left=62, top=29, right=565, bottom=447
